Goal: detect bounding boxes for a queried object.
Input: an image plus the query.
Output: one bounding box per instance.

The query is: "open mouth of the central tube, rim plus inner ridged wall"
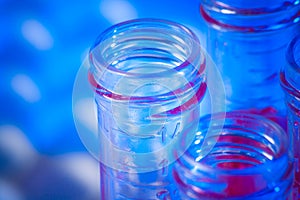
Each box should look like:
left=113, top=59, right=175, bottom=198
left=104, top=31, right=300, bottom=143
left=90, top=18, right=205, bottom=79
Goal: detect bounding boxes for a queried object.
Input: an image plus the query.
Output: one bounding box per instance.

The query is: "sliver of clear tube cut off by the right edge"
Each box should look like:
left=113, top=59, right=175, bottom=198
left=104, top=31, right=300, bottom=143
left=280, top=36, right=300, bottom=199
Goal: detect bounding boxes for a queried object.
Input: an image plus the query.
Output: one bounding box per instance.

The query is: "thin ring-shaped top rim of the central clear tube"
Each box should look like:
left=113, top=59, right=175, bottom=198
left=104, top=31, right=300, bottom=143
left=89, top=18, right=205, bottom=79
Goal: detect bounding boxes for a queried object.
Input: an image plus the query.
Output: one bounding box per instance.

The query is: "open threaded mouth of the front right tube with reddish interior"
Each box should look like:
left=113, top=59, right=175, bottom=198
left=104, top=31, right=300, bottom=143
left=179, top=112, right=289, bottom=175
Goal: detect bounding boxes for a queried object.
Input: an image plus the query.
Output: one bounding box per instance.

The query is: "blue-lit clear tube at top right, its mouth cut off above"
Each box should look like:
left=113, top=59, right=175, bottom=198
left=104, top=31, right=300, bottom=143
left=200, top=0, right=300, bottom=127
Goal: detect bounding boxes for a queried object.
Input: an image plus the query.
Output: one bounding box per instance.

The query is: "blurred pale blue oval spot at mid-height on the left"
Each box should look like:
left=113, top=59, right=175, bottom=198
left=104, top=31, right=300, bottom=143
left=11, top=74, right=41, bottom=103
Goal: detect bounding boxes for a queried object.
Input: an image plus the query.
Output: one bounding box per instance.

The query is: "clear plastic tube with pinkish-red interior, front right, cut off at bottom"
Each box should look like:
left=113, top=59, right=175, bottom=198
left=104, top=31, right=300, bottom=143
left=173, top=112, right=294, bottom=200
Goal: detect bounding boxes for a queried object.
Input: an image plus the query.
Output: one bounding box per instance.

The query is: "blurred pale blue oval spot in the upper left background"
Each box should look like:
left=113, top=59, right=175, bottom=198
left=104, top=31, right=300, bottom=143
left=22, top=20, right=53, bottom=50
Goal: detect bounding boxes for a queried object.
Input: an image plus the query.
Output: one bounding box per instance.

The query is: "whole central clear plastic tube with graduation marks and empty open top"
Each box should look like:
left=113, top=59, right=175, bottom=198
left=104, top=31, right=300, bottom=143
left=89, top=19, right=206, bottom=200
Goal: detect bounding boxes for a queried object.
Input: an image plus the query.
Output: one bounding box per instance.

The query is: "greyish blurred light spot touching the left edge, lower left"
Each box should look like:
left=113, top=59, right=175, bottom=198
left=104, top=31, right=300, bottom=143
left=0, top=125, right=37, bottom=170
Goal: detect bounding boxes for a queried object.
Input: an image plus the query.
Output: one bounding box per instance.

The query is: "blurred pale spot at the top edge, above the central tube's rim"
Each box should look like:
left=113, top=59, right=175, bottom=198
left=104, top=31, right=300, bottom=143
left=100, top=0, right=137, bottom=24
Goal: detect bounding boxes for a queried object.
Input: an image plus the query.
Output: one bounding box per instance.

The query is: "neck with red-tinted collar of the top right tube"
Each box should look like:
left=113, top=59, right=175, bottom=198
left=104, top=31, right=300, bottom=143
left=200, top=0, right=300, bottom=33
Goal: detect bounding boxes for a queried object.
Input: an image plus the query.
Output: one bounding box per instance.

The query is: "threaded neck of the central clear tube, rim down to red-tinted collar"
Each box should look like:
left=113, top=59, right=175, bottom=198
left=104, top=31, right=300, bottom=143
left=89, top=19, right=206, bottom=106
